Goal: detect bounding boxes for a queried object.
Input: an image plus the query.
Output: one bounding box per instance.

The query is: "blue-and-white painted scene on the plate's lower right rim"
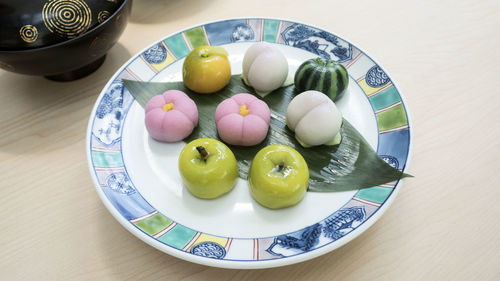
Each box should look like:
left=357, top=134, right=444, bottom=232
left=266, top=206, right=366, bottom=257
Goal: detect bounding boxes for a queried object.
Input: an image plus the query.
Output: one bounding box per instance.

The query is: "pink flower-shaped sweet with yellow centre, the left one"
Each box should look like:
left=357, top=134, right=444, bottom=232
left=146, top=90, right=198, bottom=142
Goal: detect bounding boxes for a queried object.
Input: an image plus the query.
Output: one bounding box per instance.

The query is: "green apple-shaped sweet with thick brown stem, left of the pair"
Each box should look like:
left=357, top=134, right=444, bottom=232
left=179, top=138, right=238, bottom=199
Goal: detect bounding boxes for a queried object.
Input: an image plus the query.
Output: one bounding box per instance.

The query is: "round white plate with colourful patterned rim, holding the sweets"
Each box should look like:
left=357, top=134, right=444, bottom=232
left=87, top=18, right=411, bottom=268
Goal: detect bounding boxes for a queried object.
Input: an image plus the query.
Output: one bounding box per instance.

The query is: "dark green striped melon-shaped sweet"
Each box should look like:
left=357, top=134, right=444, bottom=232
left=294, top=58, right=349, bottom=101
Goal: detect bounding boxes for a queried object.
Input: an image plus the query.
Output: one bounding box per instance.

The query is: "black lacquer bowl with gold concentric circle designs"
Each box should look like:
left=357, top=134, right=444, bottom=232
left=0, top=0, right=132, bottom=81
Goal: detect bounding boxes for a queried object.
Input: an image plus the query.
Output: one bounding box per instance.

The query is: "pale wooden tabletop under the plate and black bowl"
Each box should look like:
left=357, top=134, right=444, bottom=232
left=0, top=0, right=500, bottom=280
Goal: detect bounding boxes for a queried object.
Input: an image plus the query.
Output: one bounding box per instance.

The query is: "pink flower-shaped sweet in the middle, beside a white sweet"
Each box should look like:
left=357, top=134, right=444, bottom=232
left=215, top=94, right=271, bottom=146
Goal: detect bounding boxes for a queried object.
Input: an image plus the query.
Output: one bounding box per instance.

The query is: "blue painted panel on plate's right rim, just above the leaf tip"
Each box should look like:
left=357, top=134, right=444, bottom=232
left=377, top=129, right=410, bottom=169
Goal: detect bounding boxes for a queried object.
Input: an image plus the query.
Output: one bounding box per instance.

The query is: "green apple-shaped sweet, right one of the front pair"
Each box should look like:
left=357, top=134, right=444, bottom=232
left=248, top=144, right=309, bottom=209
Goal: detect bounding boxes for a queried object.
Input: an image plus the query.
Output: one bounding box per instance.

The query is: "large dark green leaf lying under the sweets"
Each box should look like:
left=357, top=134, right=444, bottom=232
left=123, top=75, right=410, bottom=192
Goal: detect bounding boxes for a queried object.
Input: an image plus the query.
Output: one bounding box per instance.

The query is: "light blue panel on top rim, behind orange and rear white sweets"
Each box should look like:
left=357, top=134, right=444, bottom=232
left=205, top=20, right=249, bottom=46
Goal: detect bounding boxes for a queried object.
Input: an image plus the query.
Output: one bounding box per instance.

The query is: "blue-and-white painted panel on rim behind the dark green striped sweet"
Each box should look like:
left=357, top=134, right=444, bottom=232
left=281, top=24, right=352, bottom=62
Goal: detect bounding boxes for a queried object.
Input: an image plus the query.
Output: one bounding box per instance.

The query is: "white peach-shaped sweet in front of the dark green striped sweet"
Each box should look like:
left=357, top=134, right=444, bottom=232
left=286, top=90, right=342, bottom=147
